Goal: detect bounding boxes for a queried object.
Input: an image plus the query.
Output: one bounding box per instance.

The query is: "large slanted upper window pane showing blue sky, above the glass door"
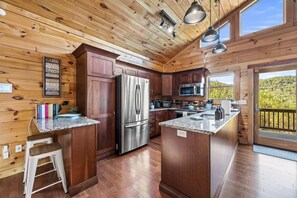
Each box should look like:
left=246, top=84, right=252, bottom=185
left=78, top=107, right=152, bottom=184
left=240, top=0, right=285, bottom=36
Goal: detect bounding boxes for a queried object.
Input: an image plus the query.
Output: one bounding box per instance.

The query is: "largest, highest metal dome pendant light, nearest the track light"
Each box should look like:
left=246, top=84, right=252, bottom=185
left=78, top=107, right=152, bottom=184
left=184, top=0, right=206, bottom=24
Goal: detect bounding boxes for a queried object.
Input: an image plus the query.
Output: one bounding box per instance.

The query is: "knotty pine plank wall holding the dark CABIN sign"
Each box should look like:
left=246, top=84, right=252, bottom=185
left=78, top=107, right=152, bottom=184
left=0, top=2, right=163, bottom=178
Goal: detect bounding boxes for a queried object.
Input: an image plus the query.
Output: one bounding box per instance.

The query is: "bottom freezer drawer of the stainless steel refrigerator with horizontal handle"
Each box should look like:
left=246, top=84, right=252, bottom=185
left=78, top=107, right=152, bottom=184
left=118, top=121, right=149, bottom=155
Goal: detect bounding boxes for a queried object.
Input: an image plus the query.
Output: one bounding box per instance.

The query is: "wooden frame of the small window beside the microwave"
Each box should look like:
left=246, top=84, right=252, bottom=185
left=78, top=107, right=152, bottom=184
left=206, top=71, right=236, bottom=100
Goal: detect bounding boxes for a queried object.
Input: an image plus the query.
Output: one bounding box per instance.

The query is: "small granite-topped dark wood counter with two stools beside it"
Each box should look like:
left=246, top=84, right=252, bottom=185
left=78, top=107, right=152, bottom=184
left=33, top=117, right=100, bottom=196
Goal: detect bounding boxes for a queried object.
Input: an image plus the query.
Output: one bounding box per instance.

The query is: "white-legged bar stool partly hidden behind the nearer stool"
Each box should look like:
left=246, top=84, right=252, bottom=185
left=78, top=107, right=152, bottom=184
left=23, top=133, right=56, bottom=183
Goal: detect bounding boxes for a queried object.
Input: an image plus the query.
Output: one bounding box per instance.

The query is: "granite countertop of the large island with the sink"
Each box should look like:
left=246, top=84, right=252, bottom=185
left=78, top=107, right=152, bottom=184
left=159, top=111, right=240, bottom=135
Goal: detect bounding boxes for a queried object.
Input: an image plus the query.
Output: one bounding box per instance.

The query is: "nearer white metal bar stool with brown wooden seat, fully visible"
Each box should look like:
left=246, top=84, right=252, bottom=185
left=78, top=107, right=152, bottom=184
left=25, top=143, right=68, bottom=198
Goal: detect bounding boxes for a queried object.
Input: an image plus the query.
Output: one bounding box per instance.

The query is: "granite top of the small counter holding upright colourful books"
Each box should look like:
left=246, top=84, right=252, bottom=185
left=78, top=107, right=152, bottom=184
left=33, top=117, right=100, bottom=133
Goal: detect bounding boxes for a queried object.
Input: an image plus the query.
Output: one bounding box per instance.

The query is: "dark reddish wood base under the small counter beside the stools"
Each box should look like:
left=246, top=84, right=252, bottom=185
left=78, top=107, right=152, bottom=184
left=54, top=124, right=100, bottom=196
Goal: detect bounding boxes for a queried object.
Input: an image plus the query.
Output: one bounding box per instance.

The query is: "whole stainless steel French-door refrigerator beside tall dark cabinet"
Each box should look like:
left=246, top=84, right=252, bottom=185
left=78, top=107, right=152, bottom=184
left=116, top=75, right=150, bottom=155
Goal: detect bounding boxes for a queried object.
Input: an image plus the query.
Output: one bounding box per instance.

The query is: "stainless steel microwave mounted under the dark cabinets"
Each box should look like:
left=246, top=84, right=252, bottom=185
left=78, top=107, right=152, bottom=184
left=179, top=83, right=204, bottom=96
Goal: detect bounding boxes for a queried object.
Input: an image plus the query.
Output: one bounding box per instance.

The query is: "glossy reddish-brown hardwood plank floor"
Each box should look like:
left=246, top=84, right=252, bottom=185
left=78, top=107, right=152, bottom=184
left=0, top=138, right=297, bottom=198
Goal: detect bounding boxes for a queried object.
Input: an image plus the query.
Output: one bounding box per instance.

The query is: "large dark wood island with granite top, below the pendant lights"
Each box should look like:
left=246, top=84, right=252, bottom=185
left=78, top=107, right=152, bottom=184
left=159, top=111, right=239, bottom=198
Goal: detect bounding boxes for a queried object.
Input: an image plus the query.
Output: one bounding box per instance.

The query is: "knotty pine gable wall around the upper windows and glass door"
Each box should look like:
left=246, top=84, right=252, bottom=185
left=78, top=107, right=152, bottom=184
left=164, top=0, right=297, bottom=144
